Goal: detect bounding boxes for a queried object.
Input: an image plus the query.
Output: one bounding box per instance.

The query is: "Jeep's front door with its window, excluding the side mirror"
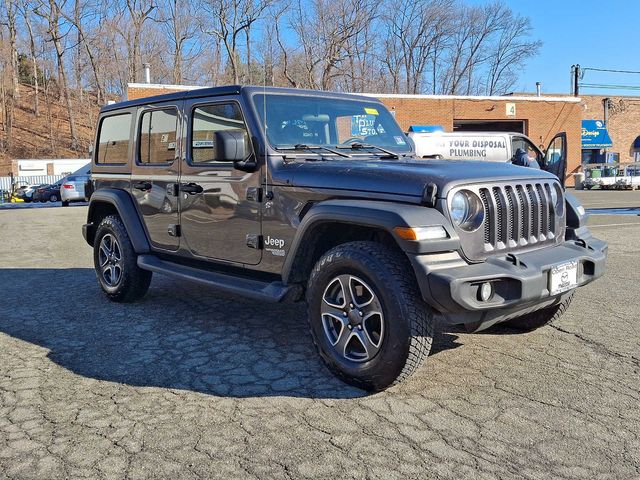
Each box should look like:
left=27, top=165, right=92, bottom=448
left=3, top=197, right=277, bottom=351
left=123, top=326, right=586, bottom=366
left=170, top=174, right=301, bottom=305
left=180, top=97, right=262, bottom=265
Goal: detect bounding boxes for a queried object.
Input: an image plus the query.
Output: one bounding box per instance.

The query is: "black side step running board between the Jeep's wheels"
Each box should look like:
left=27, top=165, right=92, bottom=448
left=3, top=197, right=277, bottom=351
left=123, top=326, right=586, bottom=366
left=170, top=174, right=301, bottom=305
left=138, top=255, right=300, bottom=303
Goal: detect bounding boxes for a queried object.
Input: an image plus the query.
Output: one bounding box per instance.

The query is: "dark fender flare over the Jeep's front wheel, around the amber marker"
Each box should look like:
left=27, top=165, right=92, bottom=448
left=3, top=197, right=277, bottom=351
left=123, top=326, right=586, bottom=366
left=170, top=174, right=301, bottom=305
left=282, top=200, right=460, bottom=284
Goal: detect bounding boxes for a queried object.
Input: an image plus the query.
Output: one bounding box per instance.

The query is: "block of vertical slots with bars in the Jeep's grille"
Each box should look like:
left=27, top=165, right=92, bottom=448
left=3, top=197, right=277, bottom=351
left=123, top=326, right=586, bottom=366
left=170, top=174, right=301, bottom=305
left=478, top=181, right=558, bottom=253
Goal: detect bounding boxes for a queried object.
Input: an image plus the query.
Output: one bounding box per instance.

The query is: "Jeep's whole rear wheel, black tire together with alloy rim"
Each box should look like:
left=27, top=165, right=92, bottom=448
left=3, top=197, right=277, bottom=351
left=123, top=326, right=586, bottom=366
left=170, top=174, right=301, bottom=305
left=93, top=215, right=152, bottom=302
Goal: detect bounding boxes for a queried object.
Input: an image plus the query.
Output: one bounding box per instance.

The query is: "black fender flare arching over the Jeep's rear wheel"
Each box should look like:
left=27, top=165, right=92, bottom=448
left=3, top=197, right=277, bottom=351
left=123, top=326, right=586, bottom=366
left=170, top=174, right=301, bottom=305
left=83, top=188, right=151, bottom=254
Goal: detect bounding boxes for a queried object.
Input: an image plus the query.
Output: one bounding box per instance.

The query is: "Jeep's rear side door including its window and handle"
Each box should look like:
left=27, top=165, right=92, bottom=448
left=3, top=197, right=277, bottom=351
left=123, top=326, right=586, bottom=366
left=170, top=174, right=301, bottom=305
left=131, top=104, right=181, bottom=250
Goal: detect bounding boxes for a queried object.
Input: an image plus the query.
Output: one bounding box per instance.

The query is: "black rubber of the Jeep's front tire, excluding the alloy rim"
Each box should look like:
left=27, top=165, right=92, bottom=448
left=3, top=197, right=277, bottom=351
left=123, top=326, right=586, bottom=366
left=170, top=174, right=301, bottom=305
left=307, top=241, right=434, bottom=391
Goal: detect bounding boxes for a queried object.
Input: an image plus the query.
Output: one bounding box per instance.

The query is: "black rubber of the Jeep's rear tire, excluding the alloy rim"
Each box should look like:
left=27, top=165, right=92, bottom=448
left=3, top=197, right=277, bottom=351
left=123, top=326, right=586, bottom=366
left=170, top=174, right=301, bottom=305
left=93, top=215, right=152, bottom=303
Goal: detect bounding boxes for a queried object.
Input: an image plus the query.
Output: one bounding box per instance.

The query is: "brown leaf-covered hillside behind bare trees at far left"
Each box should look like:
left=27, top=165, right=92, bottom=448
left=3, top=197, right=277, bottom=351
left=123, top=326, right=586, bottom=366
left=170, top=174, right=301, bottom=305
left=0, top=85, right=111, bottom=176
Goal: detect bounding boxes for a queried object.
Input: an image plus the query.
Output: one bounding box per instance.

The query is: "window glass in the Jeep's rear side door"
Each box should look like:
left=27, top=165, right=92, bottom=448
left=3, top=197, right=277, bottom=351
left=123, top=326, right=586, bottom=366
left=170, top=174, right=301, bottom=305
left=138, top=108, right=178, bottom=165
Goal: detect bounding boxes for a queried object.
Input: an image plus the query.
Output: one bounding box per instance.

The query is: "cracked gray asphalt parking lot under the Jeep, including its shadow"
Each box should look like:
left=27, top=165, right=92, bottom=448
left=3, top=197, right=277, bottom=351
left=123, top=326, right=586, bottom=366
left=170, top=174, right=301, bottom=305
left=0, top=192, right=640, bottom=479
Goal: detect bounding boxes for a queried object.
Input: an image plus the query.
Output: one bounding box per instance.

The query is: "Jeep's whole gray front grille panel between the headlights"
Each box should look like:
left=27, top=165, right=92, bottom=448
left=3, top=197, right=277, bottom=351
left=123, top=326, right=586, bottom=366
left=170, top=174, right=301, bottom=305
left=450, top=180, right=564, bottom=260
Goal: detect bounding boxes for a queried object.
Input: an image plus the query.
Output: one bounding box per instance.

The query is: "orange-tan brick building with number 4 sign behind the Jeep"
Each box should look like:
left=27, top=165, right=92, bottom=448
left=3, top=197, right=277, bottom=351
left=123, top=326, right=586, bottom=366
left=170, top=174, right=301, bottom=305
left=128, top=84, right=583, bottom=184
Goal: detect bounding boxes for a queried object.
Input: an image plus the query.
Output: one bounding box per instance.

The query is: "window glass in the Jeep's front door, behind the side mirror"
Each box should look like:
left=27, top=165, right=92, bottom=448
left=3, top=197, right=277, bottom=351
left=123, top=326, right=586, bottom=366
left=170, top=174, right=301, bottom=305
left=190, top=103, right=249, bottom=165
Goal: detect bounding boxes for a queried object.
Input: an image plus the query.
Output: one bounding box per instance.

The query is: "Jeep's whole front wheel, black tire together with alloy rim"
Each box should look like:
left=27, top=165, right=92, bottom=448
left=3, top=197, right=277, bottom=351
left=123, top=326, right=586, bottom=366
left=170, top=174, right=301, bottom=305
left=307, top=241, right=434, bottom=391
